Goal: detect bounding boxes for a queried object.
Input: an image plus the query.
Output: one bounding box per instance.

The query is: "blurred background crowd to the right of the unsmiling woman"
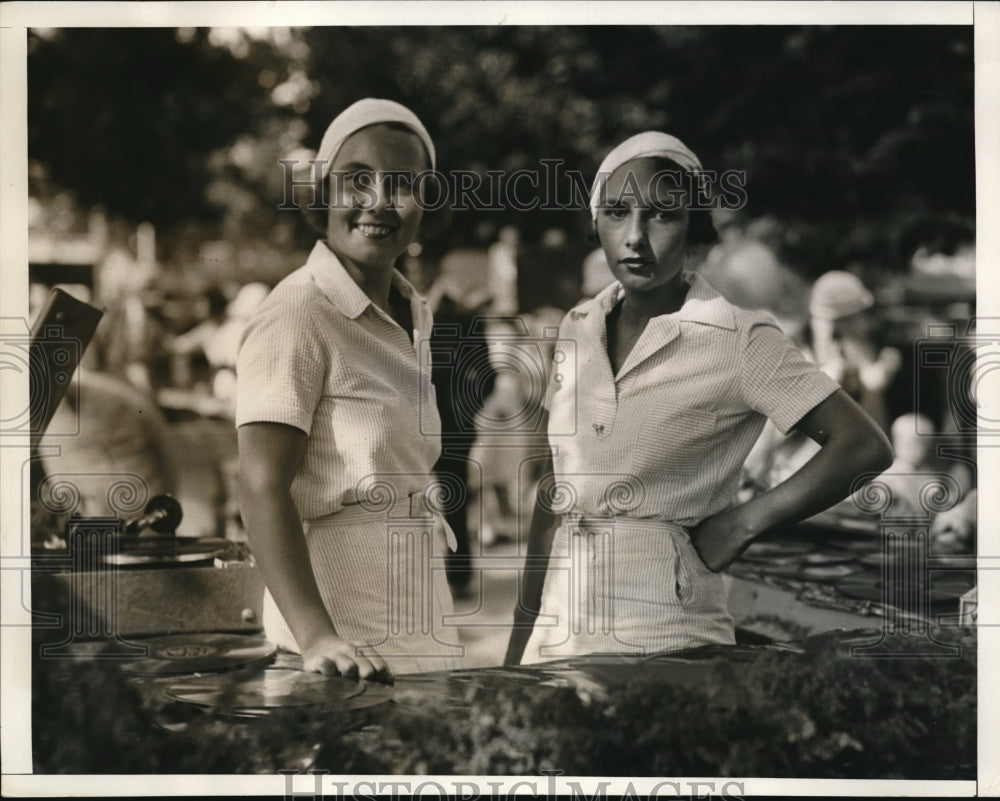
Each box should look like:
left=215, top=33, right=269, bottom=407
left=699, top=212, right=976, bottom=553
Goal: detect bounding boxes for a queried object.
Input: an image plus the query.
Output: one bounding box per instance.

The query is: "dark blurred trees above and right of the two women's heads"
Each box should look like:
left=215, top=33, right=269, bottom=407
left=305, top=26, right=975, bottom=275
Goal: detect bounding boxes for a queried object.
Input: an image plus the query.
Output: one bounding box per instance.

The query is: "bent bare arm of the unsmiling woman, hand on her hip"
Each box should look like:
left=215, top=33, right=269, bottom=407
left=691, top=389, right=892, bottom=571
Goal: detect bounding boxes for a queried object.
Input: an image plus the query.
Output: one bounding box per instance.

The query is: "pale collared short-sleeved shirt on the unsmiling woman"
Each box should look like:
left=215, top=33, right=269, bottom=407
left=546, top=273, right=838, bottom=526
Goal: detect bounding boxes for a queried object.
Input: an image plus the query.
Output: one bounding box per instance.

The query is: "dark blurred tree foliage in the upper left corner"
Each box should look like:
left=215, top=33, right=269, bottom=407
left=28, top=28, right=292, bottom=260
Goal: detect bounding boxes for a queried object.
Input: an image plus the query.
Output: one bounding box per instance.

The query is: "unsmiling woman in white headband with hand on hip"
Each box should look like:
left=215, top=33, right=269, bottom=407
left=506, top=131, right=892, bottom=664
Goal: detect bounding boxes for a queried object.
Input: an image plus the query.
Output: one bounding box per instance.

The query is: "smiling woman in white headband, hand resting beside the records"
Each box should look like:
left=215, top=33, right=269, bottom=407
left=236, top=98, right=458, bottom=679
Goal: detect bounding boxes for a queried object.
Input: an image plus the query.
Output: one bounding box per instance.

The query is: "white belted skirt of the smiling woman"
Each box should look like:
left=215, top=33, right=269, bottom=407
left=263, top=507, right=462, bottom=675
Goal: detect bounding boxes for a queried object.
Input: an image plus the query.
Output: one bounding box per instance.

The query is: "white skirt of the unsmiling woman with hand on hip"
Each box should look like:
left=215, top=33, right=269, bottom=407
left=521, top=516, right=735, bottom=664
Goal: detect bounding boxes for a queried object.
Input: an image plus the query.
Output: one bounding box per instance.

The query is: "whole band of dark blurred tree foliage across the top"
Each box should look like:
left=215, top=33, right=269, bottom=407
left=29, top=26, right=975, bottom=275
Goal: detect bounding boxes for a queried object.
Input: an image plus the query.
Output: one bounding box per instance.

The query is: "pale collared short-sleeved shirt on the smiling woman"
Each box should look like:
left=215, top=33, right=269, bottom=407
left=236, top=242, right=441, bottom=519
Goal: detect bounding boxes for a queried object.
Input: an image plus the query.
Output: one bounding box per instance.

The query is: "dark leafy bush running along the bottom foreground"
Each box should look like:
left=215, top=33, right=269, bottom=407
left=34, top=630, right=976, bottom=779
